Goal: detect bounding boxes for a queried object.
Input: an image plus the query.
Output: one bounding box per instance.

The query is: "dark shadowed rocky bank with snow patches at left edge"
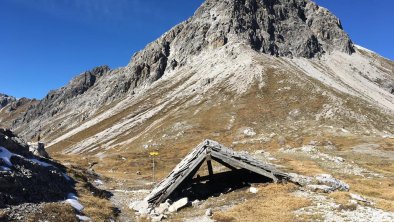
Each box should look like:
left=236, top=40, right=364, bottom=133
left=0, top=129, right=75, bottom=208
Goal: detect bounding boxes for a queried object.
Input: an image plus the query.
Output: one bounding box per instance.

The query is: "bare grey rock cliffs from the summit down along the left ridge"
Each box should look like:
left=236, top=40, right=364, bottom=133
left=3, top=0, right=360, bottom=140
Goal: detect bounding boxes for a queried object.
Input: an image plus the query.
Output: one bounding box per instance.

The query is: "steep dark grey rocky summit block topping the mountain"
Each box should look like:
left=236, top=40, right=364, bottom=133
left=193, top=0, right=354, bottom=58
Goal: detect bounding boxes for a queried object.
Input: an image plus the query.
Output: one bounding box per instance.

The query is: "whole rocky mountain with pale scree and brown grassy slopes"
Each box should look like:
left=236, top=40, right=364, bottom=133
left=0, top=0, right=394, bottom=155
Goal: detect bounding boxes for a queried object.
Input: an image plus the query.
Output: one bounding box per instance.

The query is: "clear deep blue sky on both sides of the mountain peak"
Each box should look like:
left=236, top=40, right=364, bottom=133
left=0, top=0, right=394, bottom=98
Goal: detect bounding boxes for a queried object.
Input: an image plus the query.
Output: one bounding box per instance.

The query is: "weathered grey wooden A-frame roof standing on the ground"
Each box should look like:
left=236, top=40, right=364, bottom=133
left=145, top=140, right=289, bottom=206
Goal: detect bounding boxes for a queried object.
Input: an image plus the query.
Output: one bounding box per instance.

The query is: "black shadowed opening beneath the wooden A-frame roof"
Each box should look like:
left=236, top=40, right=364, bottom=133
left=169, top=169, right=273, bottom=201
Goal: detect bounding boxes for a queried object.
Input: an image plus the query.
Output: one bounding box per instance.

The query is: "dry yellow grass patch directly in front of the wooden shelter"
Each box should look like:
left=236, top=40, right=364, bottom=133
left=213, top=184, right=310, bottom=222
